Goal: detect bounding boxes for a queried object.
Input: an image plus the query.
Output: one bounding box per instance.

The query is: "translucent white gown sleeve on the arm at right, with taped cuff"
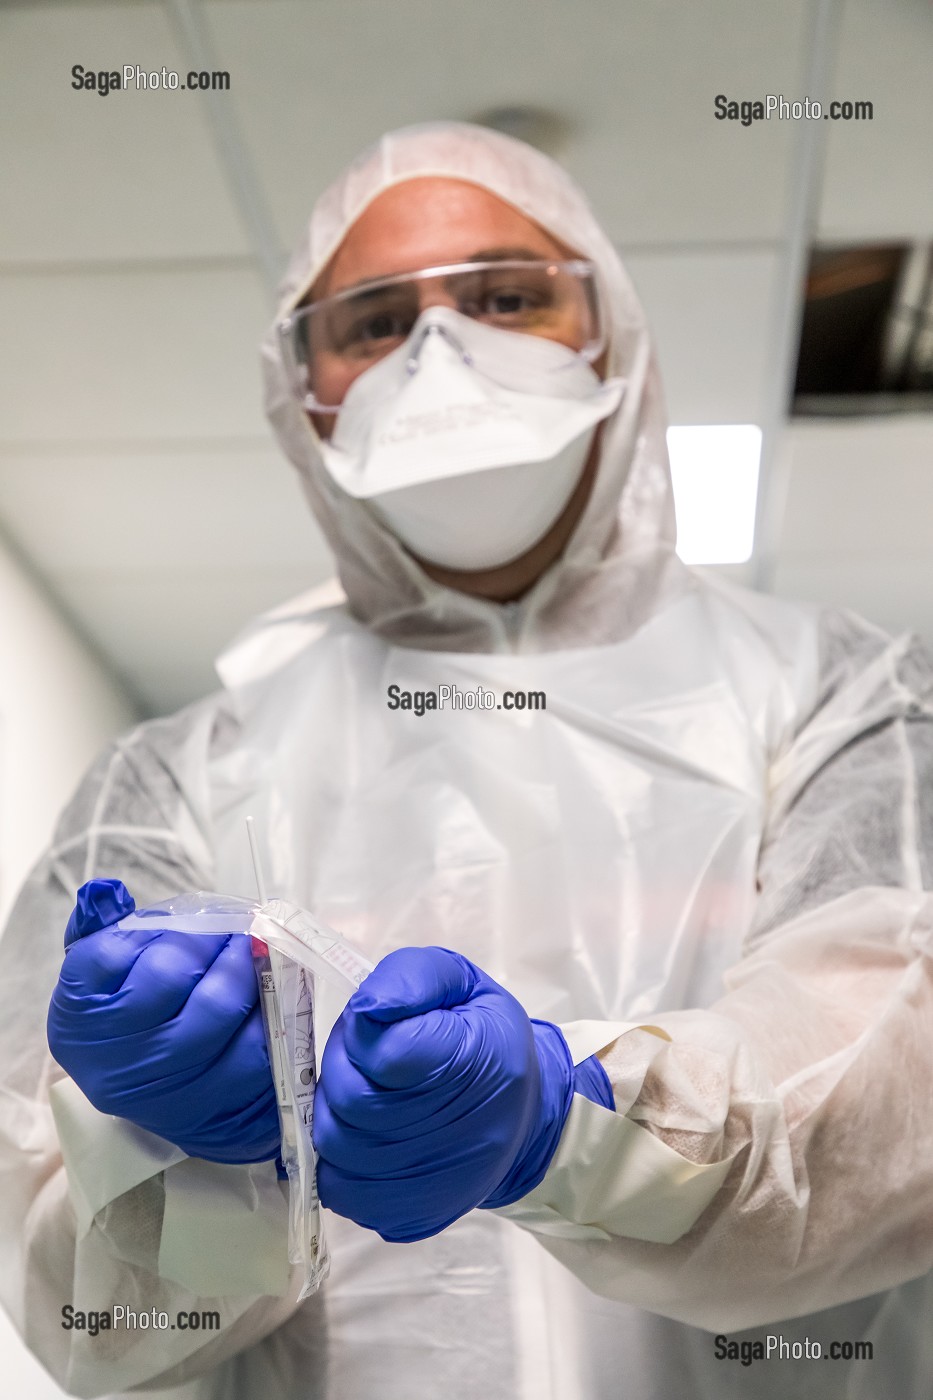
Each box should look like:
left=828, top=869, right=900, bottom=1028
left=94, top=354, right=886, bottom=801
left=502, top=613, right=933, bottom=1331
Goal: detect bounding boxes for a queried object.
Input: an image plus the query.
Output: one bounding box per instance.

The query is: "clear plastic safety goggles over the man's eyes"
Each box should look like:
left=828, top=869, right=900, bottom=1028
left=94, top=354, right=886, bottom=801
left=277, top=258, right=607, bottom=413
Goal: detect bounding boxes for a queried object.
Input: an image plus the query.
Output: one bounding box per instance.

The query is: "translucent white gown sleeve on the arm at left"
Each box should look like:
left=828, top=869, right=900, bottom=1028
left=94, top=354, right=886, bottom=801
left=0, top=704, right=297, bottom=1396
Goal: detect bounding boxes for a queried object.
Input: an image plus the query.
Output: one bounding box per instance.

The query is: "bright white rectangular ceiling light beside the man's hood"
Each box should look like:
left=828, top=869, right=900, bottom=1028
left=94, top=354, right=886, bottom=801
left=667, top=423, right=761, bottom=564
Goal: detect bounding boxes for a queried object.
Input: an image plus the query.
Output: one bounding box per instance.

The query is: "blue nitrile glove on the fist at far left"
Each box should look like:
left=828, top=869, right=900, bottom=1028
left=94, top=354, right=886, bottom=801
left=48, top=881, right=280, bottom=1162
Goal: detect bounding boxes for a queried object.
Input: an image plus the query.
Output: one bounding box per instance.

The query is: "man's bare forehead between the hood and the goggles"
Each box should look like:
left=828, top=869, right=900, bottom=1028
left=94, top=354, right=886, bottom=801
left=314, top=176, right=570, bottom=297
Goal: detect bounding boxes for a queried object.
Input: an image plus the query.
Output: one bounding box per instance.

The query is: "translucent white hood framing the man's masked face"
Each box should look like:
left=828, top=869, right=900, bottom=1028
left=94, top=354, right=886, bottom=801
left=262, top=122, right=684, bottom=651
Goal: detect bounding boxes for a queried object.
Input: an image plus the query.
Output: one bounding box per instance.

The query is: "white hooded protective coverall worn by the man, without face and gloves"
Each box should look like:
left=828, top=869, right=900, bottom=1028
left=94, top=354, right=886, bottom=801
left=0, top=125, right=933, bottom=1400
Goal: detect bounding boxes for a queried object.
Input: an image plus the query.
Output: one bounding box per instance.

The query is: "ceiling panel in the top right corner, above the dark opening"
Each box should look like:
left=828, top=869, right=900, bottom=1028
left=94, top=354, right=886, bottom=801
left=820, top=0, right=933, bottom=242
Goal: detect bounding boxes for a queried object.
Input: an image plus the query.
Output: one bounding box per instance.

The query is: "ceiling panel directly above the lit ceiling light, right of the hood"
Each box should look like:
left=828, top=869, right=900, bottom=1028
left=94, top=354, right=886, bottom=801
left=613, top=251, right=778, bottom=423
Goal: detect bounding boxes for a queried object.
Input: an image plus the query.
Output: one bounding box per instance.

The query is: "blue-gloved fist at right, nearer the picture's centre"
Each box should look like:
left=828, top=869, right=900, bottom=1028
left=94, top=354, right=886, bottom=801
left=314, top=948, right=614, bottom=1240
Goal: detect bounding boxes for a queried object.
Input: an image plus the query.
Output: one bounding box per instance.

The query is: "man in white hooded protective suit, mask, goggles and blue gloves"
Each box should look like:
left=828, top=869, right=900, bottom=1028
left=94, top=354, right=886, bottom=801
left=0, top=123, right=933, bottom=1400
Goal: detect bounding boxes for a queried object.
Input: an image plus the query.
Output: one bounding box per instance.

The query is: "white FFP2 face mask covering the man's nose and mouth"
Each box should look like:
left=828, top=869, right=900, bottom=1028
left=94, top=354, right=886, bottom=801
left=316, top=307, right=625, bottom=570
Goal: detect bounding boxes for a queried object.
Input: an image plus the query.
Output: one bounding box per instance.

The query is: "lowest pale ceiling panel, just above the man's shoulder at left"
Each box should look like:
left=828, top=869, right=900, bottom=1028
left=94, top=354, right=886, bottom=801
left=63, top=566, right=326, bottom=711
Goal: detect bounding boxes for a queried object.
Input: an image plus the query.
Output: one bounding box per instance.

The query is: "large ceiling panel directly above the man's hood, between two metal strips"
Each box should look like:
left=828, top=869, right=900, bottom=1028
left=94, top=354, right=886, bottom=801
left=206, top=0, right=807, bottom=245
